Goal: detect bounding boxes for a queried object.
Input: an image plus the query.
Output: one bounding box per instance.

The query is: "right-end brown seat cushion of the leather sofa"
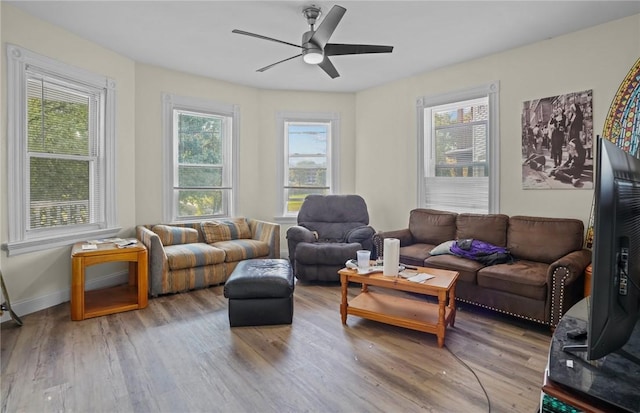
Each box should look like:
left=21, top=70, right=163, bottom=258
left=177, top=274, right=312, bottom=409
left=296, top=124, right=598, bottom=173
left=478, top=260, right=549, bottom=301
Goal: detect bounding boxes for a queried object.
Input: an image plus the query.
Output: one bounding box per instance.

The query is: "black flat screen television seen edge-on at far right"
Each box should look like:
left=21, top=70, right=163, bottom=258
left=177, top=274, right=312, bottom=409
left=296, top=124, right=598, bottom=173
left=569, top=137, right=640, bottom=362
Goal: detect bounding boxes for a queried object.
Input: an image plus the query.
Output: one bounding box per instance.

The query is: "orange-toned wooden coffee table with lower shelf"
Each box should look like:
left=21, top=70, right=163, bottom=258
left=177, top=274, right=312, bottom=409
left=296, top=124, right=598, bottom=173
left=338, top=267, right=458, bottom=347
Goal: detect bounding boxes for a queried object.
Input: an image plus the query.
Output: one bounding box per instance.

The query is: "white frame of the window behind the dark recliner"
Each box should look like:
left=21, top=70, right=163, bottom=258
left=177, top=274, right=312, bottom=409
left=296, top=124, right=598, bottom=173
left=274, top=112, right=340, bottom=224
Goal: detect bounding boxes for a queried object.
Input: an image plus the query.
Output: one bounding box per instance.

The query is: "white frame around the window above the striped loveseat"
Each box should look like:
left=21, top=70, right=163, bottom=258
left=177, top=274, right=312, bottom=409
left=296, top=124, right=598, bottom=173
left=162, top=93, right=240, bottom=222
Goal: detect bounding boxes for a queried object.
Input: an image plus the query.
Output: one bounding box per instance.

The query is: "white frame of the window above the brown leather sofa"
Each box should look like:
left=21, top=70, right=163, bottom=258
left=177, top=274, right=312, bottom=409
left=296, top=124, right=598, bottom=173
left=416, top=81, right=500, bottom=214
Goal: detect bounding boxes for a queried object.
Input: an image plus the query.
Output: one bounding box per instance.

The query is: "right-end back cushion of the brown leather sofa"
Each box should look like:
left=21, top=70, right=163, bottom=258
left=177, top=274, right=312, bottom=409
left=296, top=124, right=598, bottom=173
left=507, top=216, right=584, bottom=264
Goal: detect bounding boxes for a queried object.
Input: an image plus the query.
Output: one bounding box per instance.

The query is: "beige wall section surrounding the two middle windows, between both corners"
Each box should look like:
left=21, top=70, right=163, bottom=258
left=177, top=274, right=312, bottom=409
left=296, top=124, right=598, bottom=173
left=135, top=70, right=355, bottom=225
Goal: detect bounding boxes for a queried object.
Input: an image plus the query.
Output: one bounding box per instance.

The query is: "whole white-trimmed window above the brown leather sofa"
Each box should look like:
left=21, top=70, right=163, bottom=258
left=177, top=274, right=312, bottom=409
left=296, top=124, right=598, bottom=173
left=417, top=82, right=500, bottom=214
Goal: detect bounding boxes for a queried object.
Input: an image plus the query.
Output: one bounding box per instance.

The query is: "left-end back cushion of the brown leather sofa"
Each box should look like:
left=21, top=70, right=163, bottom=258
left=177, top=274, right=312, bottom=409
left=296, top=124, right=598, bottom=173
left=409, top=208, right=458, bottom=245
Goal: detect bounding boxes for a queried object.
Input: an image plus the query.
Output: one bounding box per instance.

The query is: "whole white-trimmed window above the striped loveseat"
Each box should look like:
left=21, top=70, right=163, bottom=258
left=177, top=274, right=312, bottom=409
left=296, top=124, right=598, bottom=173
left=163, top=94, right=239, bottom=222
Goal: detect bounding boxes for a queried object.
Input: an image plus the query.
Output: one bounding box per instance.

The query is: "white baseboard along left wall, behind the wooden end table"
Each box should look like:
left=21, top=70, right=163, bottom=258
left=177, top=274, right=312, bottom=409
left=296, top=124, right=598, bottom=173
left=0, top=271, right=129, bottom=323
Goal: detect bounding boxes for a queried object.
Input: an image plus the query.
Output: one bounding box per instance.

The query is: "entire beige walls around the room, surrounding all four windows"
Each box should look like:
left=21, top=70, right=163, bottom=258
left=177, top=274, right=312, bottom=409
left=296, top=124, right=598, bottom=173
left=0, top=3, right=640, bottom=314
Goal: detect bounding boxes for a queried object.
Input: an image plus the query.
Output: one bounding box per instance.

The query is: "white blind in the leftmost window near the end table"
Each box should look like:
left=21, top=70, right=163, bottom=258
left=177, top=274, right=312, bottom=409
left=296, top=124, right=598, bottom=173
left=25, top=69, right=105, bottom=231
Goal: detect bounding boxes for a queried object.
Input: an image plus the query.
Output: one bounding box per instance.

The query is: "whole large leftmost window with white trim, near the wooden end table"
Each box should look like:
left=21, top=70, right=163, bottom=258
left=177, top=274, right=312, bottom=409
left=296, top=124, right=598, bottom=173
left=5, top=45, right=119, bottom=255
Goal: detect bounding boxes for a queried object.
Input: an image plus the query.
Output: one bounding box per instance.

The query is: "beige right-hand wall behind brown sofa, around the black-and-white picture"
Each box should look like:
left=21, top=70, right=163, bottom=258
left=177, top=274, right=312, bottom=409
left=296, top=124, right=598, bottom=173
left=355, top=15, right=640, bottom=230
